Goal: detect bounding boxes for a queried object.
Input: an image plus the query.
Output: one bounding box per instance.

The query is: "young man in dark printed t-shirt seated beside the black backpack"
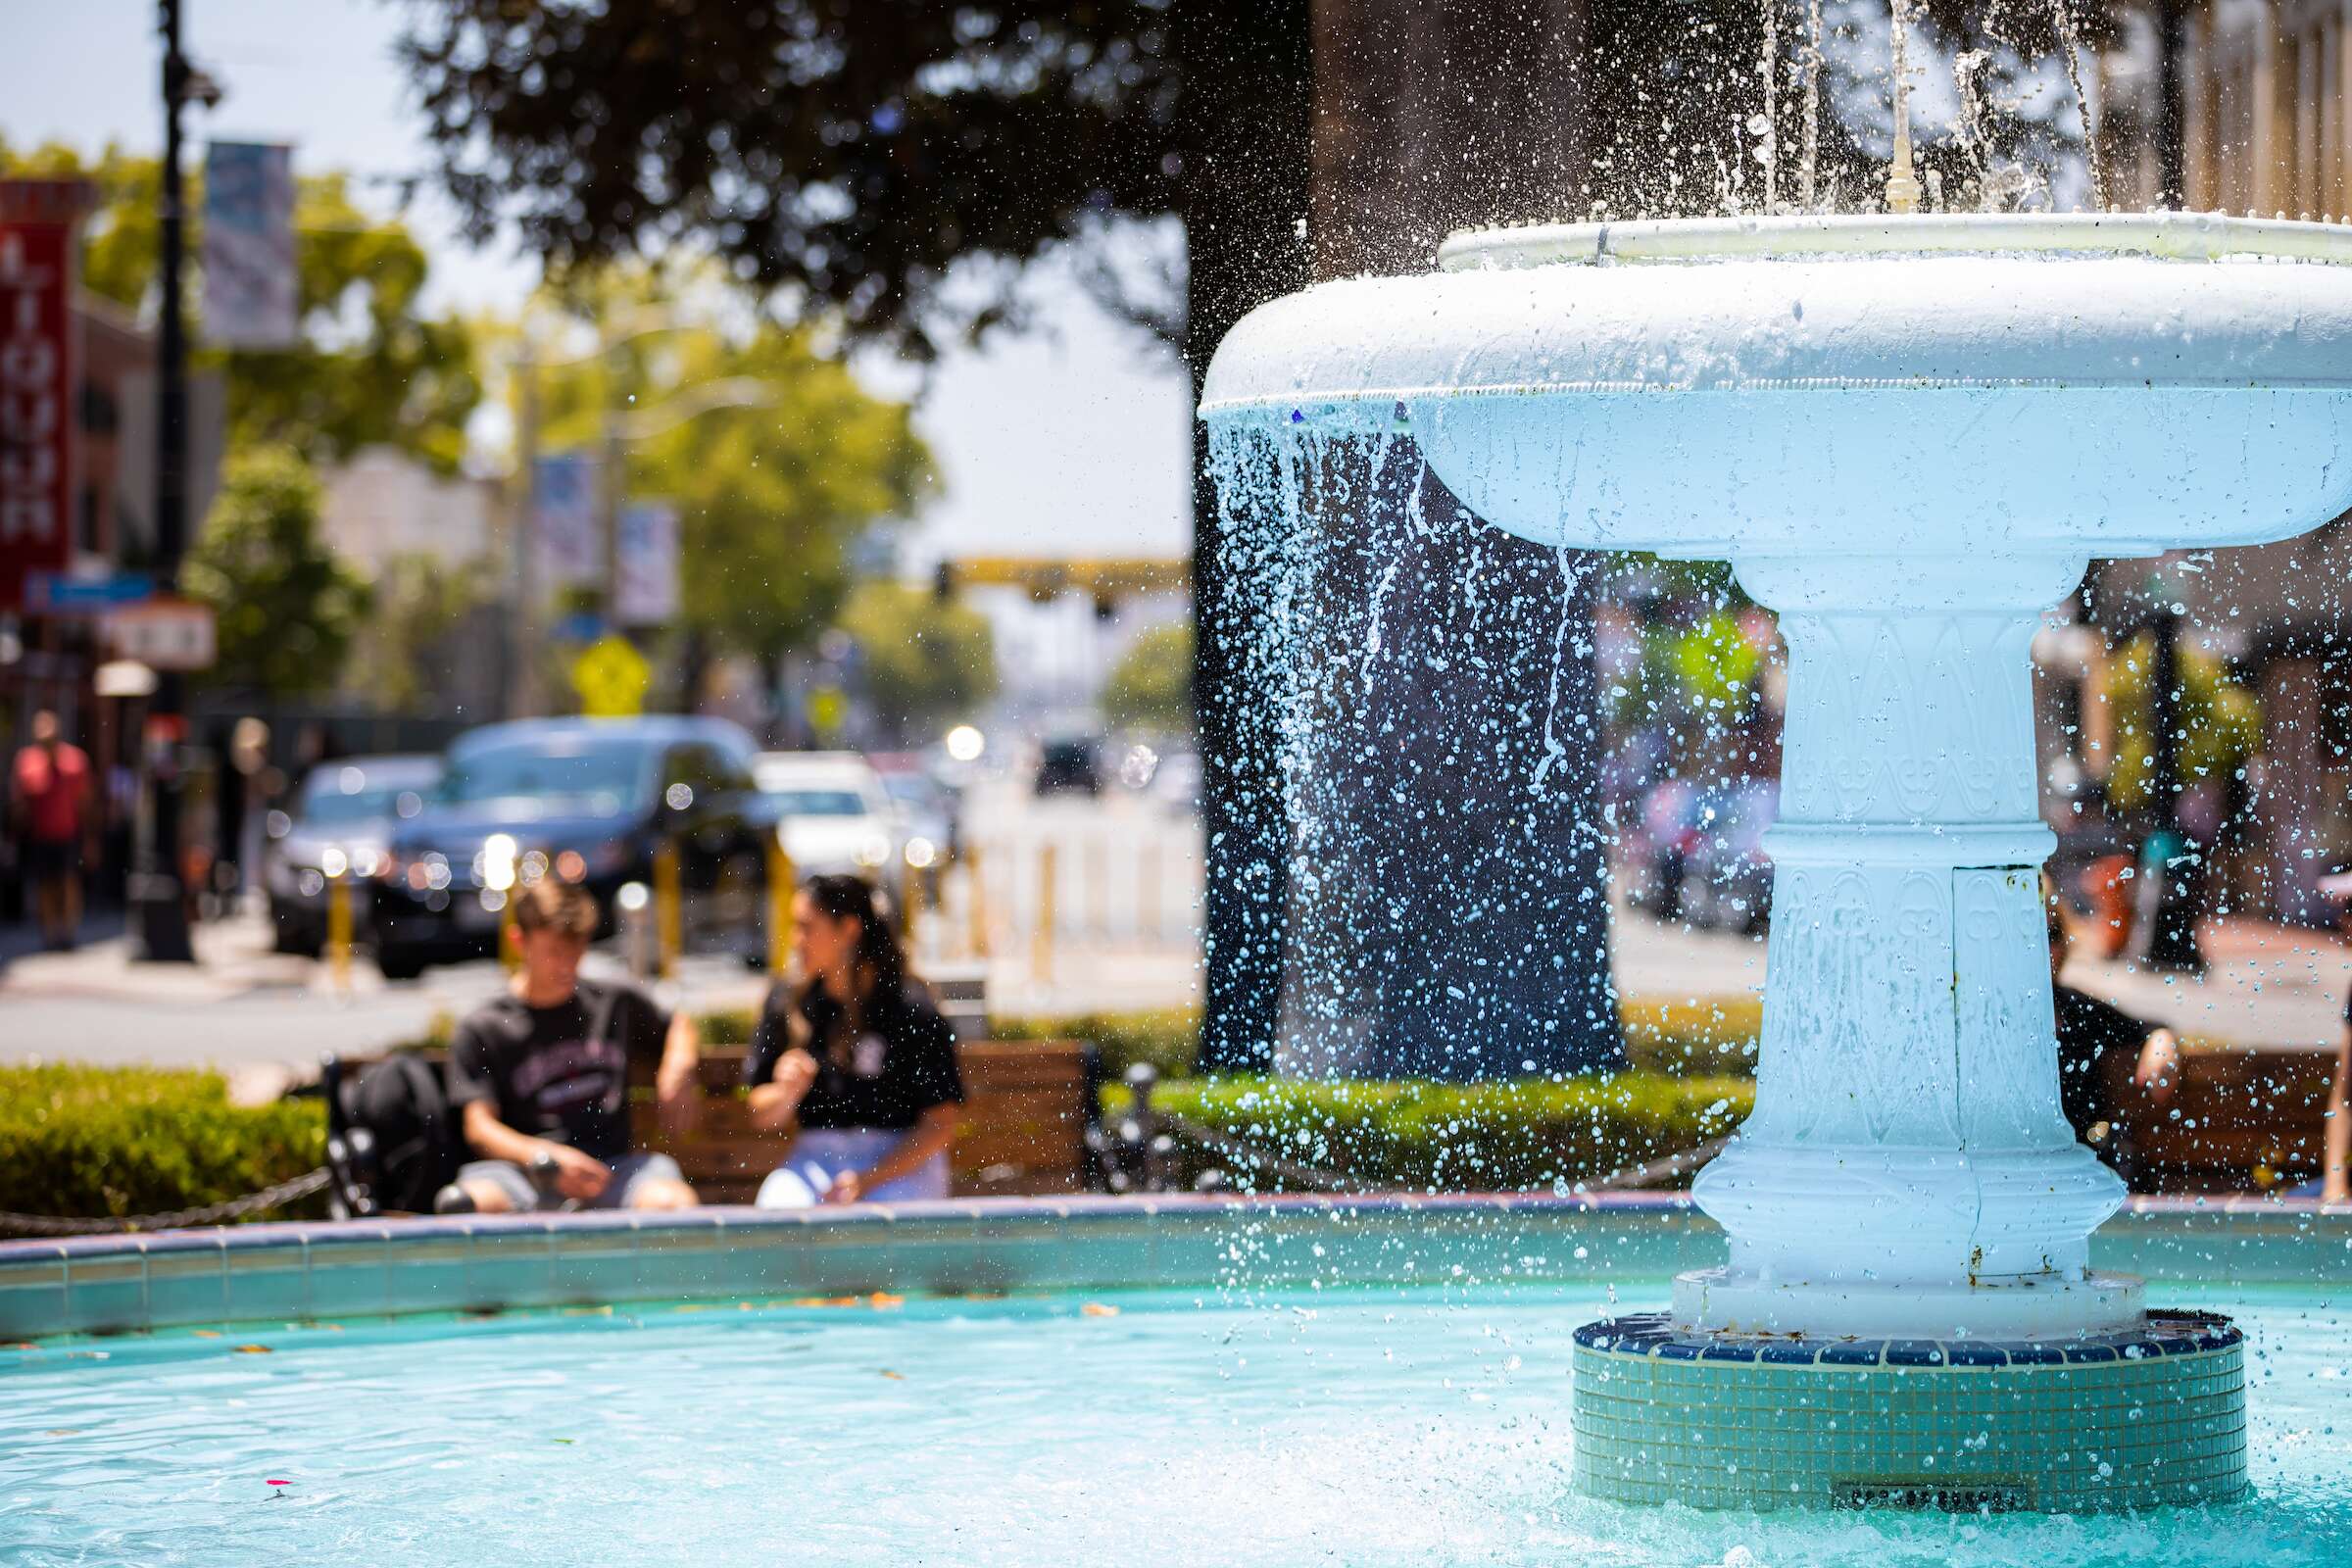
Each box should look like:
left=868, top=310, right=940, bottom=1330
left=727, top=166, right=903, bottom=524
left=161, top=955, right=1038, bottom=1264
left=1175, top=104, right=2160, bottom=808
left=435, top=879, right=701, bottom=1213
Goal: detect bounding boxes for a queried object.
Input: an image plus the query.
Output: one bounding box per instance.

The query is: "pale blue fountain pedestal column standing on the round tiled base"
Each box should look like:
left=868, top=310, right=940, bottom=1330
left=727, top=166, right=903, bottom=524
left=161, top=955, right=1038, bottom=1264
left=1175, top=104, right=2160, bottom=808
left=1675, top=555, right=2140, bottom=1338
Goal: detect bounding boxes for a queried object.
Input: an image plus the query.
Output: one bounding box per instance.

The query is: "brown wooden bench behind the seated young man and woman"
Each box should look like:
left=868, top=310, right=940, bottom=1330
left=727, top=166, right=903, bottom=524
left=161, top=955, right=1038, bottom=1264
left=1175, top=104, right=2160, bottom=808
left=343, top=1039, right=1092, bottom=1203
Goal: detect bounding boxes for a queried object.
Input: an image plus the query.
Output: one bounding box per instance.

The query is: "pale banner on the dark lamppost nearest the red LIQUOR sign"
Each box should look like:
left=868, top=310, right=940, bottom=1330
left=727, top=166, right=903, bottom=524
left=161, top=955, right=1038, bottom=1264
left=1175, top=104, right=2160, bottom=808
left=198, top=141, right=301, bottom=348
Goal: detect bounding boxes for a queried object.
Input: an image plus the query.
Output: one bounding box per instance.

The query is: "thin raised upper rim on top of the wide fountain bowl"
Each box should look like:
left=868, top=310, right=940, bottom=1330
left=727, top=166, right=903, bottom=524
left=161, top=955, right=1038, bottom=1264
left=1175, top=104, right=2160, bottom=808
left=1437, top=212, right=2352, bottom=272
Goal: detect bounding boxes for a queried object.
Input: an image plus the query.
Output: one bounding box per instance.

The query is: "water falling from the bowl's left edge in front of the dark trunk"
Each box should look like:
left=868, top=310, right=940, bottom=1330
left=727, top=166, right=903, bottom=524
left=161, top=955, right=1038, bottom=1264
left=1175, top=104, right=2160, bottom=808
left=1209, top=412, right=1618, bottom=1079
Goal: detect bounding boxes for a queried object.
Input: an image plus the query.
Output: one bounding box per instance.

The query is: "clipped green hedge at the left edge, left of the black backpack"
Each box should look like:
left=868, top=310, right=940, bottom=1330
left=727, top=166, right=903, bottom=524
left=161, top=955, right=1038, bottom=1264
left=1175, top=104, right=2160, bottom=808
left=0, top=1065, right=327, bottom=1220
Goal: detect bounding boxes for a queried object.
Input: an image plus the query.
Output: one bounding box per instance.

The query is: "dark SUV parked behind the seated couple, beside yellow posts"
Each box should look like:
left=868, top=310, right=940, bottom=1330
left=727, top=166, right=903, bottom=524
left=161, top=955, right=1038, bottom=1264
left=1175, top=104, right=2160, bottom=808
left=374, top=717, right=774, bottom=980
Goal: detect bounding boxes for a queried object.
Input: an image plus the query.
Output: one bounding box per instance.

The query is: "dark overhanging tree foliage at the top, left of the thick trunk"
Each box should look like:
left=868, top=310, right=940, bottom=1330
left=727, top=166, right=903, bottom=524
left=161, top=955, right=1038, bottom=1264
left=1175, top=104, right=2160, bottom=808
left=402, top=0, right=1181, bottom=353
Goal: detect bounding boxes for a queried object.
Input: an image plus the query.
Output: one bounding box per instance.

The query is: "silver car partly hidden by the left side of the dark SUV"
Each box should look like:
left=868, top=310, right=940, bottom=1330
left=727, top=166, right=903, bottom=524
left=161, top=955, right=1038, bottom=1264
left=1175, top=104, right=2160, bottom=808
left=261, top=757, right=442, bottom=956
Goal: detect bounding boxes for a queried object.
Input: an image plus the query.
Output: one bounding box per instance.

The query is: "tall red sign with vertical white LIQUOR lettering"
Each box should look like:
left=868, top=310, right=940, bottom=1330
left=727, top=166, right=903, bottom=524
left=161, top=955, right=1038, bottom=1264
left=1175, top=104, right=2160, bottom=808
left=0, top=181, right=89, bottom=612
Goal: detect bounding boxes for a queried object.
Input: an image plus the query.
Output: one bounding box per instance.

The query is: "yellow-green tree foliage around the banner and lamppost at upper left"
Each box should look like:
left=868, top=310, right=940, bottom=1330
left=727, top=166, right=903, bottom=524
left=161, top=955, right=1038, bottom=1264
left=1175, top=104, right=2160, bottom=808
left=0, top=143, right=482, bottom=472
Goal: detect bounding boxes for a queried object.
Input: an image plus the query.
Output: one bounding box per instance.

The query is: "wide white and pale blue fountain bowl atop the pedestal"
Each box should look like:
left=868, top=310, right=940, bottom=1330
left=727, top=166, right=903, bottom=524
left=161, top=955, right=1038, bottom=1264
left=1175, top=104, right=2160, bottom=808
left=1201, top=219, right=2352, bottom=558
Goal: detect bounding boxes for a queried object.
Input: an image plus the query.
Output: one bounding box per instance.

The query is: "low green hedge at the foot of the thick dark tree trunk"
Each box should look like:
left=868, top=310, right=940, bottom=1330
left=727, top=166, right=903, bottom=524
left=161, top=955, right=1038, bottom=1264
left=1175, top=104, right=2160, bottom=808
left=1103, top=1072, right=1754, bottom=1192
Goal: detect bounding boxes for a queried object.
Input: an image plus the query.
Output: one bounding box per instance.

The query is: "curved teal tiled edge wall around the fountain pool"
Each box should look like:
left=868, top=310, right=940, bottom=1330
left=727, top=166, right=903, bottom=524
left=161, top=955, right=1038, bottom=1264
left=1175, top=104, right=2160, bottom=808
left=0, top=1195, right=2352, bottom=1340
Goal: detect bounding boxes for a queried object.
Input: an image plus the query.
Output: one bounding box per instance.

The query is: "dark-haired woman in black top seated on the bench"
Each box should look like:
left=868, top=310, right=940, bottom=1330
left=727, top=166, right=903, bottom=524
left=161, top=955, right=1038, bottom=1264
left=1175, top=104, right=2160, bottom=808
left=743, top=877, right=964, bottom=1208
